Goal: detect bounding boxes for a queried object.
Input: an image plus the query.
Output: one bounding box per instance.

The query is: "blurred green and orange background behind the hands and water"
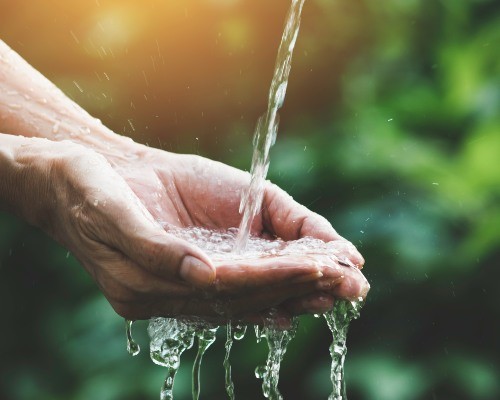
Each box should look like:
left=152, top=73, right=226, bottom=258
left=0, top=0, right=500, bottom=400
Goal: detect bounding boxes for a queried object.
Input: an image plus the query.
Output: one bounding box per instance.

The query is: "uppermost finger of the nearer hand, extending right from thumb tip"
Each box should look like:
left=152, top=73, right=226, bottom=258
left=213, top=256, right=323, bottom=293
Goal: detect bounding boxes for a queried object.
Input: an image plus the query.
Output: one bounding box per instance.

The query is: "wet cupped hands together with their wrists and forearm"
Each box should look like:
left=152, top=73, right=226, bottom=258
left=0, top=40, right=369, bottom=326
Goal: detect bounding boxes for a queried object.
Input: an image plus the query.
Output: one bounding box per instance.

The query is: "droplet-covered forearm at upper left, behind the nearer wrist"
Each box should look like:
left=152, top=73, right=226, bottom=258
left=0, top=40, right=135, bottom=155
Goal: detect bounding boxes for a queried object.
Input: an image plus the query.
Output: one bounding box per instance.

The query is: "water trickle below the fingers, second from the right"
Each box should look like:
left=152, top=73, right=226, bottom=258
left=255, top=318, right=298, bottom=400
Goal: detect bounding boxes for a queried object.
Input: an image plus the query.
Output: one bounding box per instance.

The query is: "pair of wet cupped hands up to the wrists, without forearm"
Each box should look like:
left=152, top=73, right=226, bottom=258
left=23, top=139, right=368, bottom=326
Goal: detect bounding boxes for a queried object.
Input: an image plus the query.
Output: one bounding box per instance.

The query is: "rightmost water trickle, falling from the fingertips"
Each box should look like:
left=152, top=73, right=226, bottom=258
left=324, top=297, right=364, bottom=400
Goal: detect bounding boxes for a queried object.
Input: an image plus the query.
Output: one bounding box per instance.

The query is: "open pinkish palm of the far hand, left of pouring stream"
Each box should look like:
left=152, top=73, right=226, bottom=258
left=114, top=149, right=263, bottom=236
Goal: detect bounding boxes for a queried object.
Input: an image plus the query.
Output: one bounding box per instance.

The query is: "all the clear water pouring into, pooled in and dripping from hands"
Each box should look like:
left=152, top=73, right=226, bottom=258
left=126, top=0, right=361, bottom=400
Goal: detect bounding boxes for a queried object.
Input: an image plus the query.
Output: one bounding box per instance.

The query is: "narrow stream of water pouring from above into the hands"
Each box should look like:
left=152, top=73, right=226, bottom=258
left=234, top=0, right=305, bottom=252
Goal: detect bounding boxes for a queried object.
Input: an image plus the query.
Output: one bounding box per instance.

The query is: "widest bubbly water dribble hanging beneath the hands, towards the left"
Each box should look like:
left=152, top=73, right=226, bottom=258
left=148, top=318, right=195, bottom=400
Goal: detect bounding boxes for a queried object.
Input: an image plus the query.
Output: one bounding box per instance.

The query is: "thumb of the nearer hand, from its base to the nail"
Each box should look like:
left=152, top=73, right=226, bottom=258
left=72, top=157, right=215, bottom=287
